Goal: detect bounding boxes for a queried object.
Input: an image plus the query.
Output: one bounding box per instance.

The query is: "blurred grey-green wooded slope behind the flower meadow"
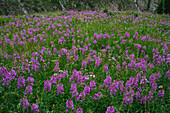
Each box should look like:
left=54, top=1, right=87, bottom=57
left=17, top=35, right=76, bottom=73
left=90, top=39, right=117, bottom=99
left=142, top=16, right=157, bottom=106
left=0, top=0, right=168, bottom=15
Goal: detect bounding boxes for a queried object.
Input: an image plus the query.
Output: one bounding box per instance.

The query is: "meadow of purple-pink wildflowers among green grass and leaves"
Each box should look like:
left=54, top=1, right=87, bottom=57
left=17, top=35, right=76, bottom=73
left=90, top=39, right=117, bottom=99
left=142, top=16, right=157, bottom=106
left=0, top=11, right=170, bottom=113
